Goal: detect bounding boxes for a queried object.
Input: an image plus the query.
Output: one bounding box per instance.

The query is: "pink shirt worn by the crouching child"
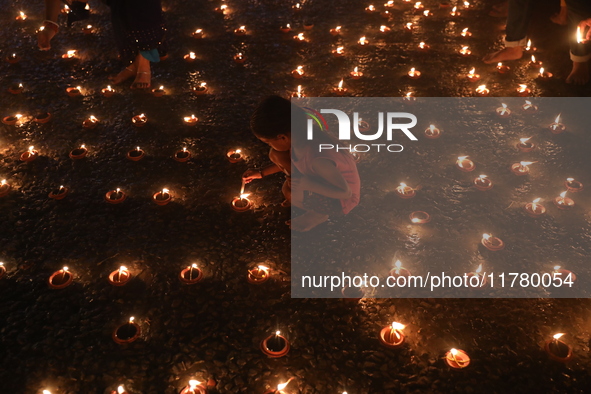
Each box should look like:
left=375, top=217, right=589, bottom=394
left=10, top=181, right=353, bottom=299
left=291, top=144, right=361, bottom=214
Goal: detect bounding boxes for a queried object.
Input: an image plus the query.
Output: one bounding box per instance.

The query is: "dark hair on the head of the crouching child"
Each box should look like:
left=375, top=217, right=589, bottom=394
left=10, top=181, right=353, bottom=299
left=250, top=96, right=306, bottom=139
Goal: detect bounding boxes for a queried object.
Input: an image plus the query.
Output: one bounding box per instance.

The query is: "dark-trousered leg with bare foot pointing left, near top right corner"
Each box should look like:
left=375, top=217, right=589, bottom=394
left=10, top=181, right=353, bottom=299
left=482, top=0, right=535, bottom=64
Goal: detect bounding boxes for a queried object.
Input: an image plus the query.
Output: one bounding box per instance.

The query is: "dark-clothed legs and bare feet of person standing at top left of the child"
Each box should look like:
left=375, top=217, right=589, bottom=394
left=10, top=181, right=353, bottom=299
left=105, top=0, right=166, bottom=89
